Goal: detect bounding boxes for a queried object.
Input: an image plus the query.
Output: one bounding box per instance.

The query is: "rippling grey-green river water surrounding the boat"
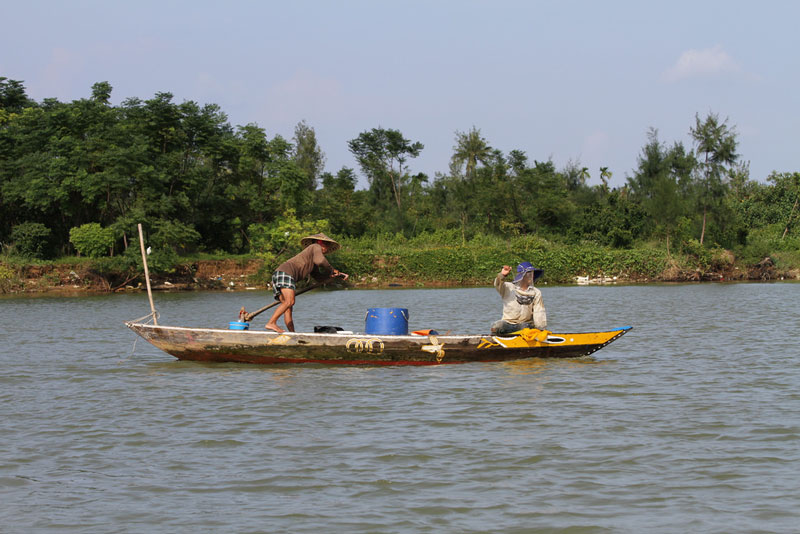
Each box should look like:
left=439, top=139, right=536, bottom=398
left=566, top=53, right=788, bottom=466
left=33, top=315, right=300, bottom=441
left=0, top=283, right=800, bottom=533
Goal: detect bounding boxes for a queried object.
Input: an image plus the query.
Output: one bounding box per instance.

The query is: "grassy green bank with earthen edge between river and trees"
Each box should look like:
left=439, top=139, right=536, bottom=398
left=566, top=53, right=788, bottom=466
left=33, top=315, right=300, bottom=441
left=0, top=234, right=800, bottom=293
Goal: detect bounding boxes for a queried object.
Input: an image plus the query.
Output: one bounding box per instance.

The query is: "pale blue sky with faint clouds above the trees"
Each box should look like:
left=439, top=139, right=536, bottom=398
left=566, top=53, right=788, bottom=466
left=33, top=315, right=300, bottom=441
left=0, top=0, right=800, bottom=187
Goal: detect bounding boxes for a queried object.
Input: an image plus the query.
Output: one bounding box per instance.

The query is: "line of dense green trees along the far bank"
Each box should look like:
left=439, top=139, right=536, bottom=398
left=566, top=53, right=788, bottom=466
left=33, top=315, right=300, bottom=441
left=0, top=78, right=800, bottom=266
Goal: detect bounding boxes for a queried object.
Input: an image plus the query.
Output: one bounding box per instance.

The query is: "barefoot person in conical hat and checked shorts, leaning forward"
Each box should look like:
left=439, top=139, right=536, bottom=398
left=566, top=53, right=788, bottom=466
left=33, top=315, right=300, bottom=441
left=265, top=234, right=349, bottom=333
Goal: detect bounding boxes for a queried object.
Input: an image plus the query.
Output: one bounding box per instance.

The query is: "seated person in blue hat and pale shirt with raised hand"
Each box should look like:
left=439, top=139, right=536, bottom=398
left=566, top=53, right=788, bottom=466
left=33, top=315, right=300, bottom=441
left=492, top=261, right=547, bottom=335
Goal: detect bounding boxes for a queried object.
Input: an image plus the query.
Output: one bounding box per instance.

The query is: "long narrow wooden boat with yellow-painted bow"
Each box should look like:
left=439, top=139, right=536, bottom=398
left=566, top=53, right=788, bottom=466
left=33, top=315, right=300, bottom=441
left=125, top=322, right=631, bottom=365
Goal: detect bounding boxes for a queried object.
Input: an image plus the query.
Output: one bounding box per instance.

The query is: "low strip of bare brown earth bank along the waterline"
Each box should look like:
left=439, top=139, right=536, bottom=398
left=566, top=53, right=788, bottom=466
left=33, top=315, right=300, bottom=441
left=0, top=255, right=800, bottom=293
